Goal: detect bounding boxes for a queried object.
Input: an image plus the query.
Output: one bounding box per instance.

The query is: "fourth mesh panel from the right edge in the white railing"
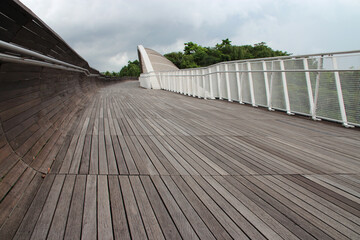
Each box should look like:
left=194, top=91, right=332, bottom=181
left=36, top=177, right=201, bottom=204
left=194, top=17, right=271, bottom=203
left=270, top=61, right=285, bottom=110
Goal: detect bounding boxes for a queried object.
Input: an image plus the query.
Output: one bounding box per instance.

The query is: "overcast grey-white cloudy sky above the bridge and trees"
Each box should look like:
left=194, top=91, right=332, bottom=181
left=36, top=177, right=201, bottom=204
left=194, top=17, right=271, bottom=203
left=21, top=0, right=360, bottom=71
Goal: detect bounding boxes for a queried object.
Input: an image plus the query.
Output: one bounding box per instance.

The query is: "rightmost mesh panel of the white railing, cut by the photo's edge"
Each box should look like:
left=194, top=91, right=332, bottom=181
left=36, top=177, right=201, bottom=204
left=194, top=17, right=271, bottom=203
left=340, top=72, right=360, bottom=124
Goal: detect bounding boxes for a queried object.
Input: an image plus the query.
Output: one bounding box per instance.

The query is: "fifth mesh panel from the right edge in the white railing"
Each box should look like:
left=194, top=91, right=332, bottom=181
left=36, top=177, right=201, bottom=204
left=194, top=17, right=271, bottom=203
left=251, top=62, right=267, bottom=106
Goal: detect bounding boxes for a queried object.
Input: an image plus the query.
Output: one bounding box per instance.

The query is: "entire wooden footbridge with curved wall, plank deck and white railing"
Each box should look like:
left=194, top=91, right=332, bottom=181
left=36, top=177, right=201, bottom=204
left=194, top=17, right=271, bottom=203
left=0, top=0, right=360, bottom=239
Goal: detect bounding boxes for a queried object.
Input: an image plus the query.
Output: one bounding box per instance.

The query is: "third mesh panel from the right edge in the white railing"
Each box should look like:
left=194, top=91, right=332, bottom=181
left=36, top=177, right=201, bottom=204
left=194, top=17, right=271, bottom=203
left=284, top=59, right=310, bottom=114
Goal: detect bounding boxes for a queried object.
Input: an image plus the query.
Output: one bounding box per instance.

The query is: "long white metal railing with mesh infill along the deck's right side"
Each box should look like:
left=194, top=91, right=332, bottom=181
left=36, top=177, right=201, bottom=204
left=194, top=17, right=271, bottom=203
left=139, top=51, right=360, bottom=127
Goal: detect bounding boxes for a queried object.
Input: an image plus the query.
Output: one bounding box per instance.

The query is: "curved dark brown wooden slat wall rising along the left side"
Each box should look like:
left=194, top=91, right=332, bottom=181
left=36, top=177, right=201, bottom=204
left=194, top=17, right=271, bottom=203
left=0, top=0, right=103, bottom=234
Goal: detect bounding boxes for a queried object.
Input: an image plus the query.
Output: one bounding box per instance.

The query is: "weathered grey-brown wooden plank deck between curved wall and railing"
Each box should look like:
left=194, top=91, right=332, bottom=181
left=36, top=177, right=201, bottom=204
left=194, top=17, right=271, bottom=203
left=1, top=82, right=360, bottom=239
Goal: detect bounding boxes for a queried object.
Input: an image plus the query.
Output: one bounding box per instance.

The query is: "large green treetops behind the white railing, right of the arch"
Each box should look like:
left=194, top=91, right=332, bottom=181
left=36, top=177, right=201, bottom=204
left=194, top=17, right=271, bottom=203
left=164, top=38, right=290, bottom=69
